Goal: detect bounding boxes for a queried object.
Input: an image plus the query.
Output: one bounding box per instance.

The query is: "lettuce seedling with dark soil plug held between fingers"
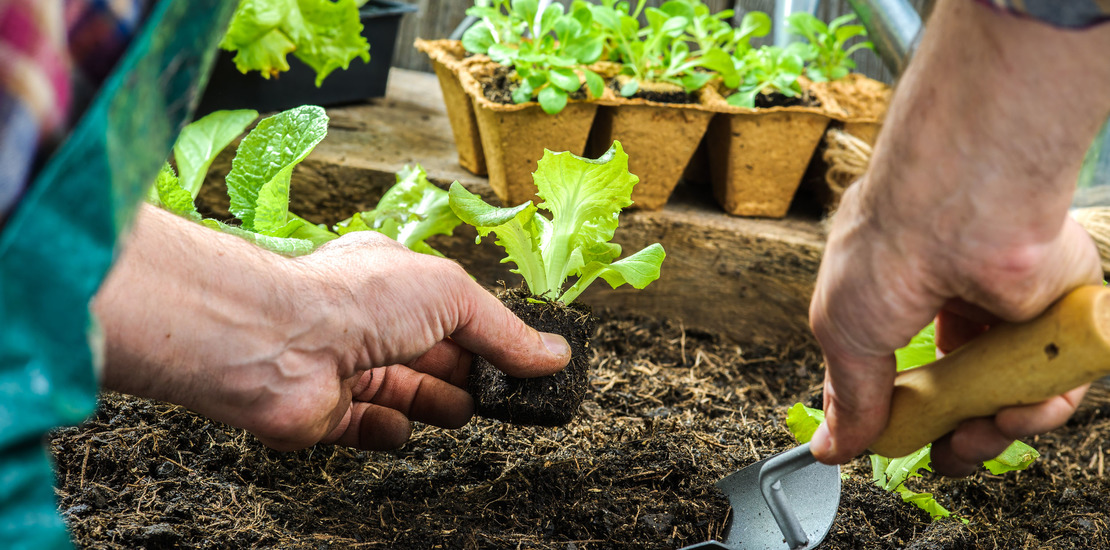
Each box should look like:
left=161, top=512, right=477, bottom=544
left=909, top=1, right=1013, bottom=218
left=450, top=142, right=666, bottom=426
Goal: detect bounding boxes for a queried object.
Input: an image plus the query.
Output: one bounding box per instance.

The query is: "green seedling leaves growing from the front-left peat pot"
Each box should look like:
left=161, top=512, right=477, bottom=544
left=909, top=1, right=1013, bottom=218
left=463, top=0, right=605, bottom=114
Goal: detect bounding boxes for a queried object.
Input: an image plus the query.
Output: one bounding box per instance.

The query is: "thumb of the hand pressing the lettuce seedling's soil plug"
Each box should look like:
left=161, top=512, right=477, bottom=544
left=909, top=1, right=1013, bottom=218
left=451, top=281, right=571, bottom=378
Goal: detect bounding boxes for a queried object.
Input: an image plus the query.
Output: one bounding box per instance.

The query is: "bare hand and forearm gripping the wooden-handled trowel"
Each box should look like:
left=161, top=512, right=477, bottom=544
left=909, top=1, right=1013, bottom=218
left=810, top=0, right=1110, bottom=474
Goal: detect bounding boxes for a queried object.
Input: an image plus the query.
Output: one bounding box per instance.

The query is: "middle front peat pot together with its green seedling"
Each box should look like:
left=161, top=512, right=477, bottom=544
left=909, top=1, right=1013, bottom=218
left=572, top=0, right=771, bottom=210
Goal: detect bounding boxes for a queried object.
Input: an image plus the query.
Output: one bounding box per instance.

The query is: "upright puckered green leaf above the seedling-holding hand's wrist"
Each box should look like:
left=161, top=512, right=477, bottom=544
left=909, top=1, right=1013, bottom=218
left=228, top=106, right=327, bottom=232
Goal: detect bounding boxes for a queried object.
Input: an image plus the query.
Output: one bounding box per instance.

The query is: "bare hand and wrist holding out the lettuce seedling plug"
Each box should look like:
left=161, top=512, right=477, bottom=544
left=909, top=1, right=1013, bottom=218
left=94, top=207, right=569, bottom=450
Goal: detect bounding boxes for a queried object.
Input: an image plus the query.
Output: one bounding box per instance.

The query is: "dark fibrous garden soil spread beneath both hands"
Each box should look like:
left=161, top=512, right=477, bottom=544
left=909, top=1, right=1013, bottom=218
left=51, top=312, right=1110, bottom=550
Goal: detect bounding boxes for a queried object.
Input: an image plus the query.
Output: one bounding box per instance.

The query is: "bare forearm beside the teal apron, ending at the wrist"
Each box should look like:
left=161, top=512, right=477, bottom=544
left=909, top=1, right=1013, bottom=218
left=94, top=207, right=315, bottom=402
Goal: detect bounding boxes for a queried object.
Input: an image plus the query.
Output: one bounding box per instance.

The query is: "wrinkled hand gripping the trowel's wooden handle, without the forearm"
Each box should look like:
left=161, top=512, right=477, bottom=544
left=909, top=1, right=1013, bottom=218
left=810, top=186, right=1101, bottom=476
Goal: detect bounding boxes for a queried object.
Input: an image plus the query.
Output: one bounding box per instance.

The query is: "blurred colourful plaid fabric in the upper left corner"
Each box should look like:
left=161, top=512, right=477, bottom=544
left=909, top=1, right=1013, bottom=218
left=0, top=0, right=149, bottom=227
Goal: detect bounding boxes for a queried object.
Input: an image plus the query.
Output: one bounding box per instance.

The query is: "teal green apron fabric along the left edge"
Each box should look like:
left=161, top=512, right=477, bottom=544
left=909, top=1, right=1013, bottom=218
left=0, top=0, right=236, bottom=550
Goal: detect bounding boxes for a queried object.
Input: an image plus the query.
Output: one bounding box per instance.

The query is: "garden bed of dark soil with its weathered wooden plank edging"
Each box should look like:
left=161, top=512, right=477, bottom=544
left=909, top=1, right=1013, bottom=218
left=51, top=71, right=1110, bottom=550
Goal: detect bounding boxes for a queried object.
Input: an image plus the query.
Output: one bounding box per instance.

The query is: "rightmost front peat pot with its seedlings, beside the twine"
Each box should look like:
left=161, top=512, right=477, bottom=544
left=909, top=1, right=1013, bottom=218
left=706, top=9, right=896, bottom=218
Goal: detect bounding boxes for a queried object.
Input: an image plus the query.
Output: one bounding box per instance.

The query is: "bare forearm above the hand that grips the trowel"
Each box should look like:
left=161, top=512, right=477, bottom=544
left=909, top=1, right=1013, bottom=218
left=867, top=0, right=1110, bottom=244
